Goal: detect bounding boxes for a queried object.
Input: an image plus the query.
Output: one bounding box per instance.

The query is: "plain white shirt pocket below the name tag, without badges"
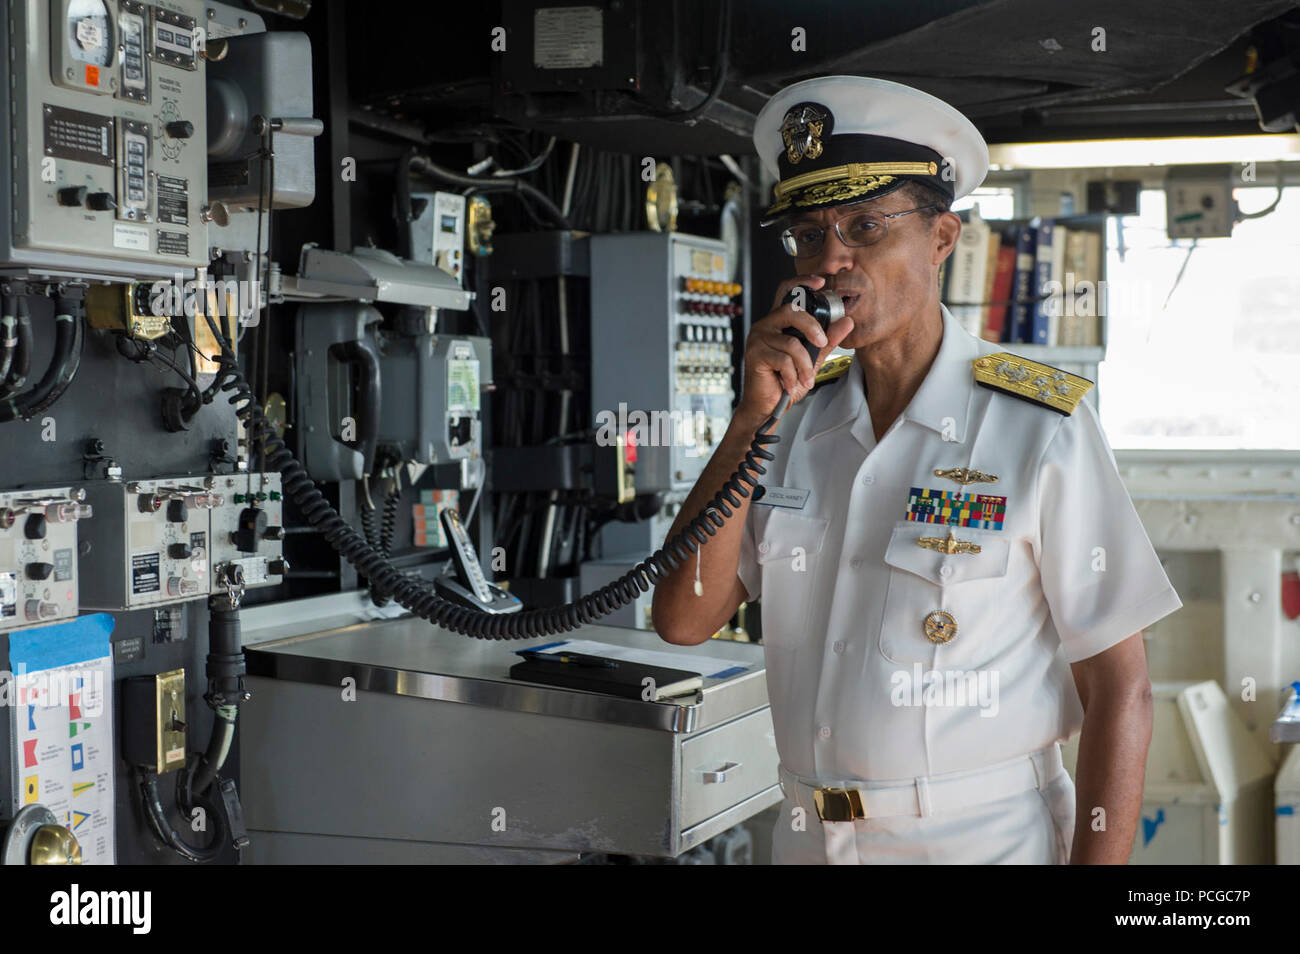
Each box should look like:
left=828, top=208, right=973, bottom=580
left=755, top=507, right=828, bottom=647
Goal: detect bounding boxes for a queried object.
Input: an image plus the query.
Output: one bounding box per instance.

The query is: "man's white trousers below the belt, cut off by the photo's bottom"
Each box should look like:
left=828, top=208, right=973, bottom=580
left=772, top=753, right=1074, bottom=864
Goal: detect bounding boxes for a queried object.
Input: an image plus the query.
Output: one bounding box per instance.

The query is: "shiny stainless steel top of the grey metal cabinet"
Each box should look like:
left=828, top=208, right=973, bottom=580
left=247, top=617, right=767, bottom=732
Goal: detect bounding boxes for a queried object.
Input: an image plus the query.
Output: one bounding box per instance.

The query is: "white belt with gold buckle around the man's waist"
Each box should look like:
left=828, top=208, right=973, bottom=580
left=779, top=742, right=1065, bottom=864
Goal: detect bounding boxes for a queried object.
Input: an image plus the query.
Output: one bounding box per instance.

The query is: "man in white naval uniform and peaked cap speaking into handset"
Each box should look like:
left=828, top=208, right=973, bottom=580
left=654, top=77, right=1182, bottom=864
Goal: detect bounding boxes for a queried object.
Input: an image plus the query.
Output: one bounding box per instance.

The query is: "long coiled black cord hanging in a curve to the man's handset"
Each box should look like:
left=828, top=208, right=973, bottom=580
left=208, top=317, right=790, bottom=639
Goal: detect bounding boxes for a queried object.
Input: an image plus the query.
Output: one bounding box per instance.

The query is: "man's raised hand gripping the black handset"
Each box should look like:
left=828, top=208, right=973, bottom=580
left=736, top=269, right=853, bottom=420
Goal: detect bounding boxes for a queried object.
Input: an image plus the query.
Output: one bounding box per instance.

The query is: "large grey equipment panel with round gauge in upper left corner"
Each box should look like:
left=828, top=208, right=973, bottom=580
left=0, top=0, right=215, bottom=278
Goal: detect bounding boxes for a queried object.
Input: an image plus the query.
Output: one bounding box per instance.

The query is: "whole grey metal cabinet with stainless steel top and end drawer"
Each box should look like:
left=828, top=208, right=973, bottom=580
left=241, top=616, right=781, bottom=863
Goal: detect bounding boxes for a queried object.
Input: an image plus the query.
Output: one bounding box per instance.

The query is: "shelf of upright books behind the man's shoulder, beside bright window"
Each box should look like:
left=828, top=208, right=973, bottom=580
left=940, top=212, right=1108, bottom=408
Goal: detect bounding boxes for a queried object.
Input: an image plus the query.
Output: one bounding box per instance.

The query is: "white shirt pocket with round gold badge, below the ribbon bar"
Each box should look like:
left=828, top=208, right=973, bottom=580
left=880, top=521, right=1011, bottom=669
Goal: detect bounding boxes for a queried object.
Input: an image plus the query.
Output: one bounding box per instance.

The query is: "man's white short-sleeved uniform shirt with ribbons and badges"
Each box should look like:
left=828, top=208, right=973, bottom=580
left=738, top=308, right=1182, bottom=781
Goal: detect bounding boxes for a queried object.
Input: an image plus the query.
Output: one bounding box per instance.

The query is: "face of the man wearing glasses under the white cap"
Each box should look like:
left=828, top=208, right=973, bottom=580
left=780, top=192, right=961, bottom=351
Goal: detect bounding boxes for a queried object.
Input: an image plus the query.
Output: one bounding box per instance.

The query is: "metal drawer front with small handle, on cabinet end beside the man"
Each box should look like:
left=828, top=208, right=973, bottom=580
left=680, top=706, right=777, bottom=831
